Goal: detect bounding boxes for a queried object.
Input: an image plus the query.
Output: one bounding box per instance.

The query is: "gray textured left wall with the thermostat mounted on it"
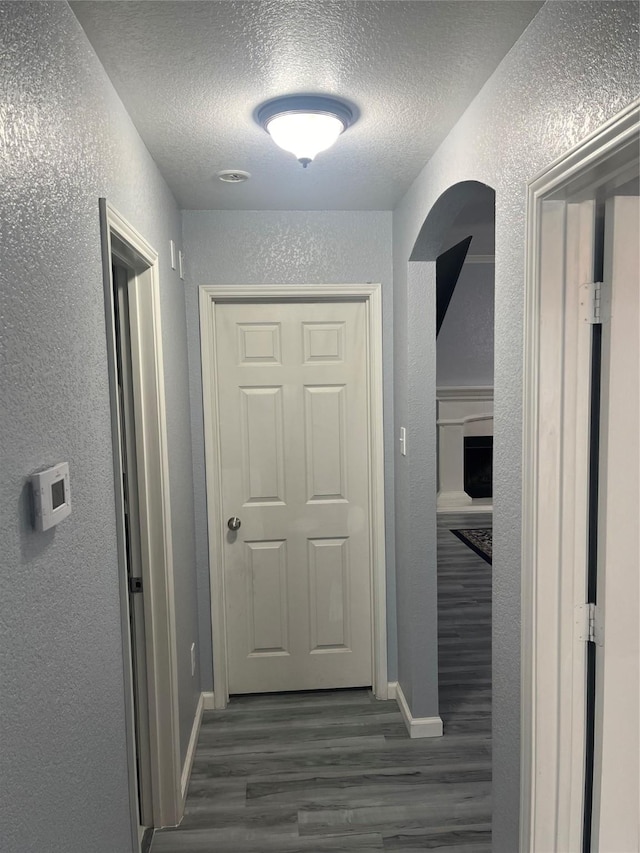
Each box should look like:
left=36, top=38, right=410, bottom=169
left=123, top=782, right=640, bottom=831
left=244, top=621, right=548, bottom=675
left=0, top=3, right=199, bottom=853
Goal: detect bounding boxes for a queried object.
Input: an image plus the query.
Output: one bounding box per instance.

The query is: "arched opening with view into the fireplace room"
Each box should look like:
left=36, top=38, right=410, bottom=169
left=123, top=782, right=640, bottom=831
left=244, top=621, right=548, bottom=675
left=435, top=185, right=495, bottom=735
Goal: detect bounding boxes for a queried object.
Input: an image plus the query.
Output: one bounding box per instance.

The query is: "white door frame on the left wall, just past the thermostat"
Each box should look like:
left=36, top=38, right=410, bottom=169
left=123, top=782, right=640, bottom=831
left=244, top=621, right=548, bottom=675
left=100, top=198, right=183, bottom=832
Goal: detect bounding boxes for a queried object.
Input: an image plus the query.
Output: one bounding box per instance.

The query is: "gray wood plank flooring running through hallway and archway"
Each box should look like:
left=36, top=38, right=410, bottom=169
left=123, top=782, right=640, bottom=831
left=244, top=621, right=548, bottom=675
left=151, top=514, right=491, bottom=853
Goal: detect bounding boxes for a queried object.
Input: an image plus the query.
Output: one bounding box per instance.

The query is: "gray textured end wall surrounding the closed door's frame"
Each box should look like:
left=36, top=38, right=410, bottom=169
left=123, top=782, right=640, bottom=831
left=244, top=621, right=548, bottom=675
left=183, top=211, right=396, bottom=690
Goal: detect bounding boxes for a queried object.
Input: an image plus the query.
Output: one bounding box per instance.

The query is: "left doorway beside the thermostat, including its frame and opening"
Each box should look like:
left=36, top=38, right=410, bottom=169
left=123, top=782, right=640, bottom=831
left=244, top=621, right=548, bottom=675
left=100, top=199, right=184, bottom=850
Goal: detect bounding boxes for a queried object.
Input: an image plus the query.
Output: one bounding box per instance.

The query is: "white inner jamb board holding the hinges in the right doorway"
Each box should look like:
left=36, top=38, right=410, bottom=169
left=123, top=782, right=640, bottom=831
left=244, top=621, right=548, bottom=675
left=526, top=201, right=595, bottom=853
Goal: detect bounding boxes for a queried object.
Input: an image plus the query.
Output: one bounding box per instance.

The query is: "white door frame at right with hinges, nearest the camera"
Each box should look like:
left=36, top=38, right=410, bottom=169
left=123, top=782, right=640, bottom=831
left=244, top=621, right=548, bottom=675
left=520, top=99, right=640, bottom=853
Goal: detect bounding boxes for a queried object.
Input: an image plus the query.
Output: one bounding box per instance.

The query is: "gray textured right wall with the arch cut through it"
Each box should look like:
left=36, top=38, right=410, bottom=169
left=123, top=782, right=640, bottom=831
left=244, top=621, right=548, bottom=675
left=394, top=2, right=640, bottom=853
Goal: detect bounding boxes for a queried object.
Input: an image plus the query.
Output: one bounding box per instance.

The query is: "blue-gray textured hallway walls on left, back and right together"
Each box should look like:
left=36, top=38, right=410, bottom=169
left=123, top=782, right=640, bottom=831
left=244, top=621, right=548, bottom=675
left=0, top=0, right=640, bottom=853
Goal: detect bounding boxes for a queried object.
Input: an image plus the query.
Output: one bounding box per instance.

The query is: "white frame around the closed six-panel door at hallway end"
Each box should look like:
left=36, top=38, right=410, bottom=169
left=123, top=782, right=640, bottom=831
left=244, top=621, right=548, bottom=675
left=199, top=284, right=387, bottom=708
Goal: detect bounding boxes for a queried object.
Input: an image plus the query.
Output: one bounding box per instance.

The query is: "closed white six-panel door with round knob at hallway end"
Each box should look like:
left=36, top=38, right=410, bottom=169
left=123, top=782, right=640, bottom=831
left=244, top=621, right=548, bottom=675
left=215, top=302, right=372, bottom=693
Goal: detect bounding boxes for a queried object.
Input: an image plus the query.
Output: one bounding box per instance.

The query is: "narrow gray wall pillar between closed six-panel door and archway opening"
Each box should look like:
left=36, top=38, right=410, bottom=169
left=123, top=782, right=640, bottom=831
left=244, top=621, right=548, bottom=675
left=394, top=263, right=438, bottom=717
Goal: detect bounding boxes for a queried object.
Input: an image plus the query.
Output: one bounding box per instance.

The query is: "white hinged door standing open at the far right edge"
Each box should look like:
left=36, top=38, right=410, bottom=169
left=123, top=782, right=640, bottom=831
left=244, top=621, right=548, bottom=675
left=592, top=196, right=640, bottom=853
